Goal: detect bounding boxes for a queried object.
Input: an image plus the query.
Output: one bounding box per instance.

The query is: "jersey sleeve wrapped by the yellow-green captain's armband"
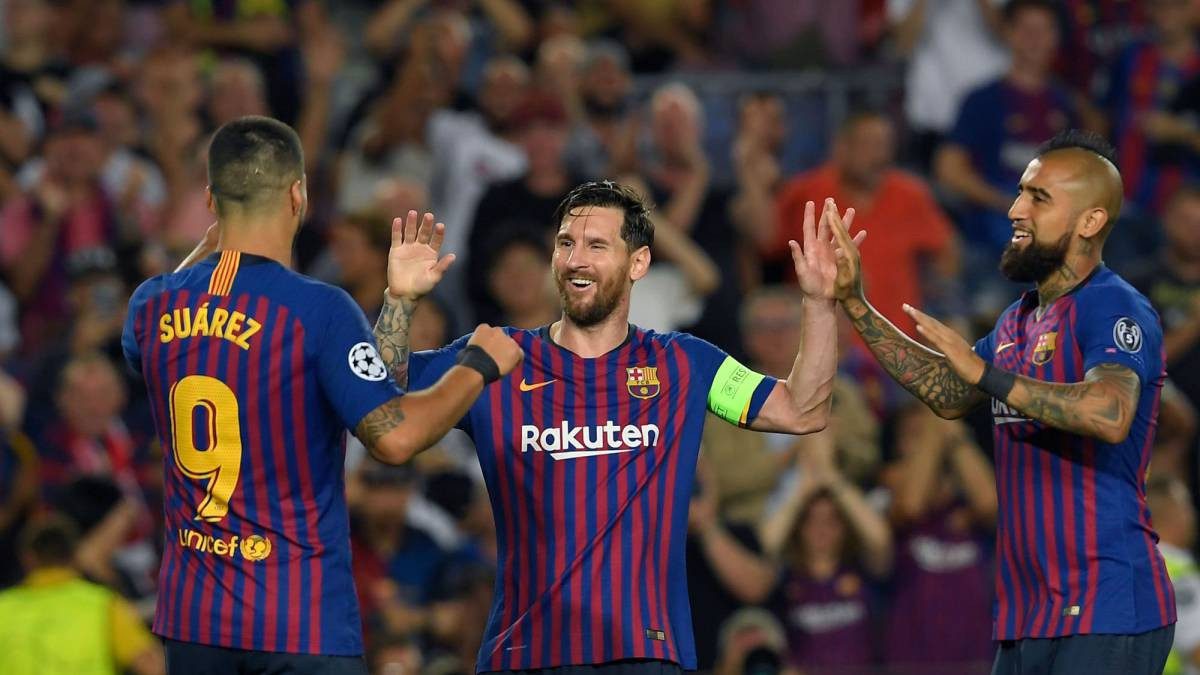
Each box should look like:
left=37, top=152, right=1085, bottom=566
left=680, top=335, right=778, bottom=426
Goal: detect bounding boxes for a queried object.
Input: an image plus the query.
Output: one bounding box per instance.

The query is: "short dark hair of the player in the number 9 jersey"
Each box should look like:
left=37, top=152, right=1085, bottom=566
left=209, top=115, right=304, bottom=213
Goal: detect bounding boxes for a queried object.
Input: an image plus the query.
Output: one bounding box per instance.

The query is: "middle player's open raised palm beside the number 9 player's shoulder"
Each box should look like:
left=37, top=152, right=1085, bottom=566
left=388, top=211, right=455, bottom=300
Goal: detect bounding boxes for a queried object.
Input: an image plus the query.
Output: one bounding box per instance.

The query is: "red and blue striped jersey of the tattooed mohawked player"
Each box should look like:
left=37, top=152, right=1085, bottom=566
left=974, top=265, right=1175, bottom=640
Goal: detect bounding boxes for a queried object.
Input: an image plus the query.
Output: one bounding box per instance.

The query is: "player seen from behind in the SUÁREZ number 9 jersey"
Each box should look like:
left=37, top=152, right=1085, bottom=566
left=121, top=118, right=517, bottom=674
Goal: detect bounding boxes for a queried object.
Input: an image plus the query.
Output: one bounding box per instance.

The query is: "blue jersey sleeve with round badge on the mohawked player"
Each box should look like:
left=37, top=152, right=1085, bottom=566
left=1075, top=281, right=1163, bottom=387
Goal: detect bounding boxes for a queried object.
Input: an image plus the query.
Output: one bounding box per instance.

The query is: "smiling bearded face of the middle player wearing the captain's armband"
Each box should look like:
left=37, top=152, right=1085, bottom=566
left=552, top=207, right=632, bottom=327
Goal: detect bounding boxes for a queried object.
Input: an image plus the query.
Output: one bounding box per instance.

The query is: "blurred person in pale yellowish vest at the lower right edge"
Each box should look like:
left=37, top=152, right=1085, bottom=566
left=1146, top=473, right=1200, bottom=675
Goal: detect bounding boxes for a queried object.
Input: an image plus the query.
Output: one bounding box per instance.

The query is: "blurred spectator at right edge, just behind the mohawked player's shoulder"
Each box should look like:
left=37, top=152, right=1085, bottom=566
left=1132, top=185, right=1200, bottom=432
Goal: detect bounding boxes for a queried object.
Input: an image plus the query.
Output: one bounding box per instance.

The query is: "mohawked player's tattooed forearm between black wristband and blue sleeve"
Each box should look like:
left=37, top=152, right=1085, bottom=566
left=1006, top=363, right=1141, bottom=440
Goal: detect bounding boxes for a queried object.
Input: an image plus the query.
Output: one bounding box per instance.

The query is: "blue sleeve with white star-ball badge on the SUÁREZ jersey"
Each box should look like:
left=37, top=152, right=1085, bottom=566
left=311, top=288, right=402, bottom=430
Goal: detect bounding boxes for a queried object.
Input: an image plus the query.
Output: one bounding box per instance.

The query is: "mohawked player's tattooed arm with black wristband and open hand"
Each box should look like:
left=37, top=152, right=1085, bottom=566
left=905, top=305, right=1141, bottom=443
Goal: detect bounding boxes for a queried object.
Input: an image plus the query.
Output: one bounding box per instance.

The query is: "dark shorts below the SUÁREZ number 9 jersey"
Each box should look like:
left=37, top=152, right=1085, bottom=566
left=162, top=639, right=367, bottom=675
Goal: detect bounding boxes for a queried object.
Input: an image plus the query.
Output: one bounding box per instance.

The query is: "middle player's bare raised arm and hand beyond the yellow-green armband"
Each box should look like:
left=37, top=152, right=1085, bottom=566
left=750, top=199, right=857, bottom=434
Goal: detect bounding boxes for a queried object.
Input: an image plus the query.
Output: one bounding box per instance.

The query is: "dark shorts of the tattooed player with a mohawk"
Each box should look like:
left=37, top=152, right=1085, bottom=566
left=991, top=623, right=1175, bottom=675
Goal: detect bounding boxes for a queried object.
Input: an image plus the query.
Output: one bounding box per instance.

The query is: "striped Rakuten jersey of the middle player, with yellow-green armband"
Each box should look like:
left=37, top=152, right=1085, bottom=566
left=409, top=327, right=775, bottom=671
